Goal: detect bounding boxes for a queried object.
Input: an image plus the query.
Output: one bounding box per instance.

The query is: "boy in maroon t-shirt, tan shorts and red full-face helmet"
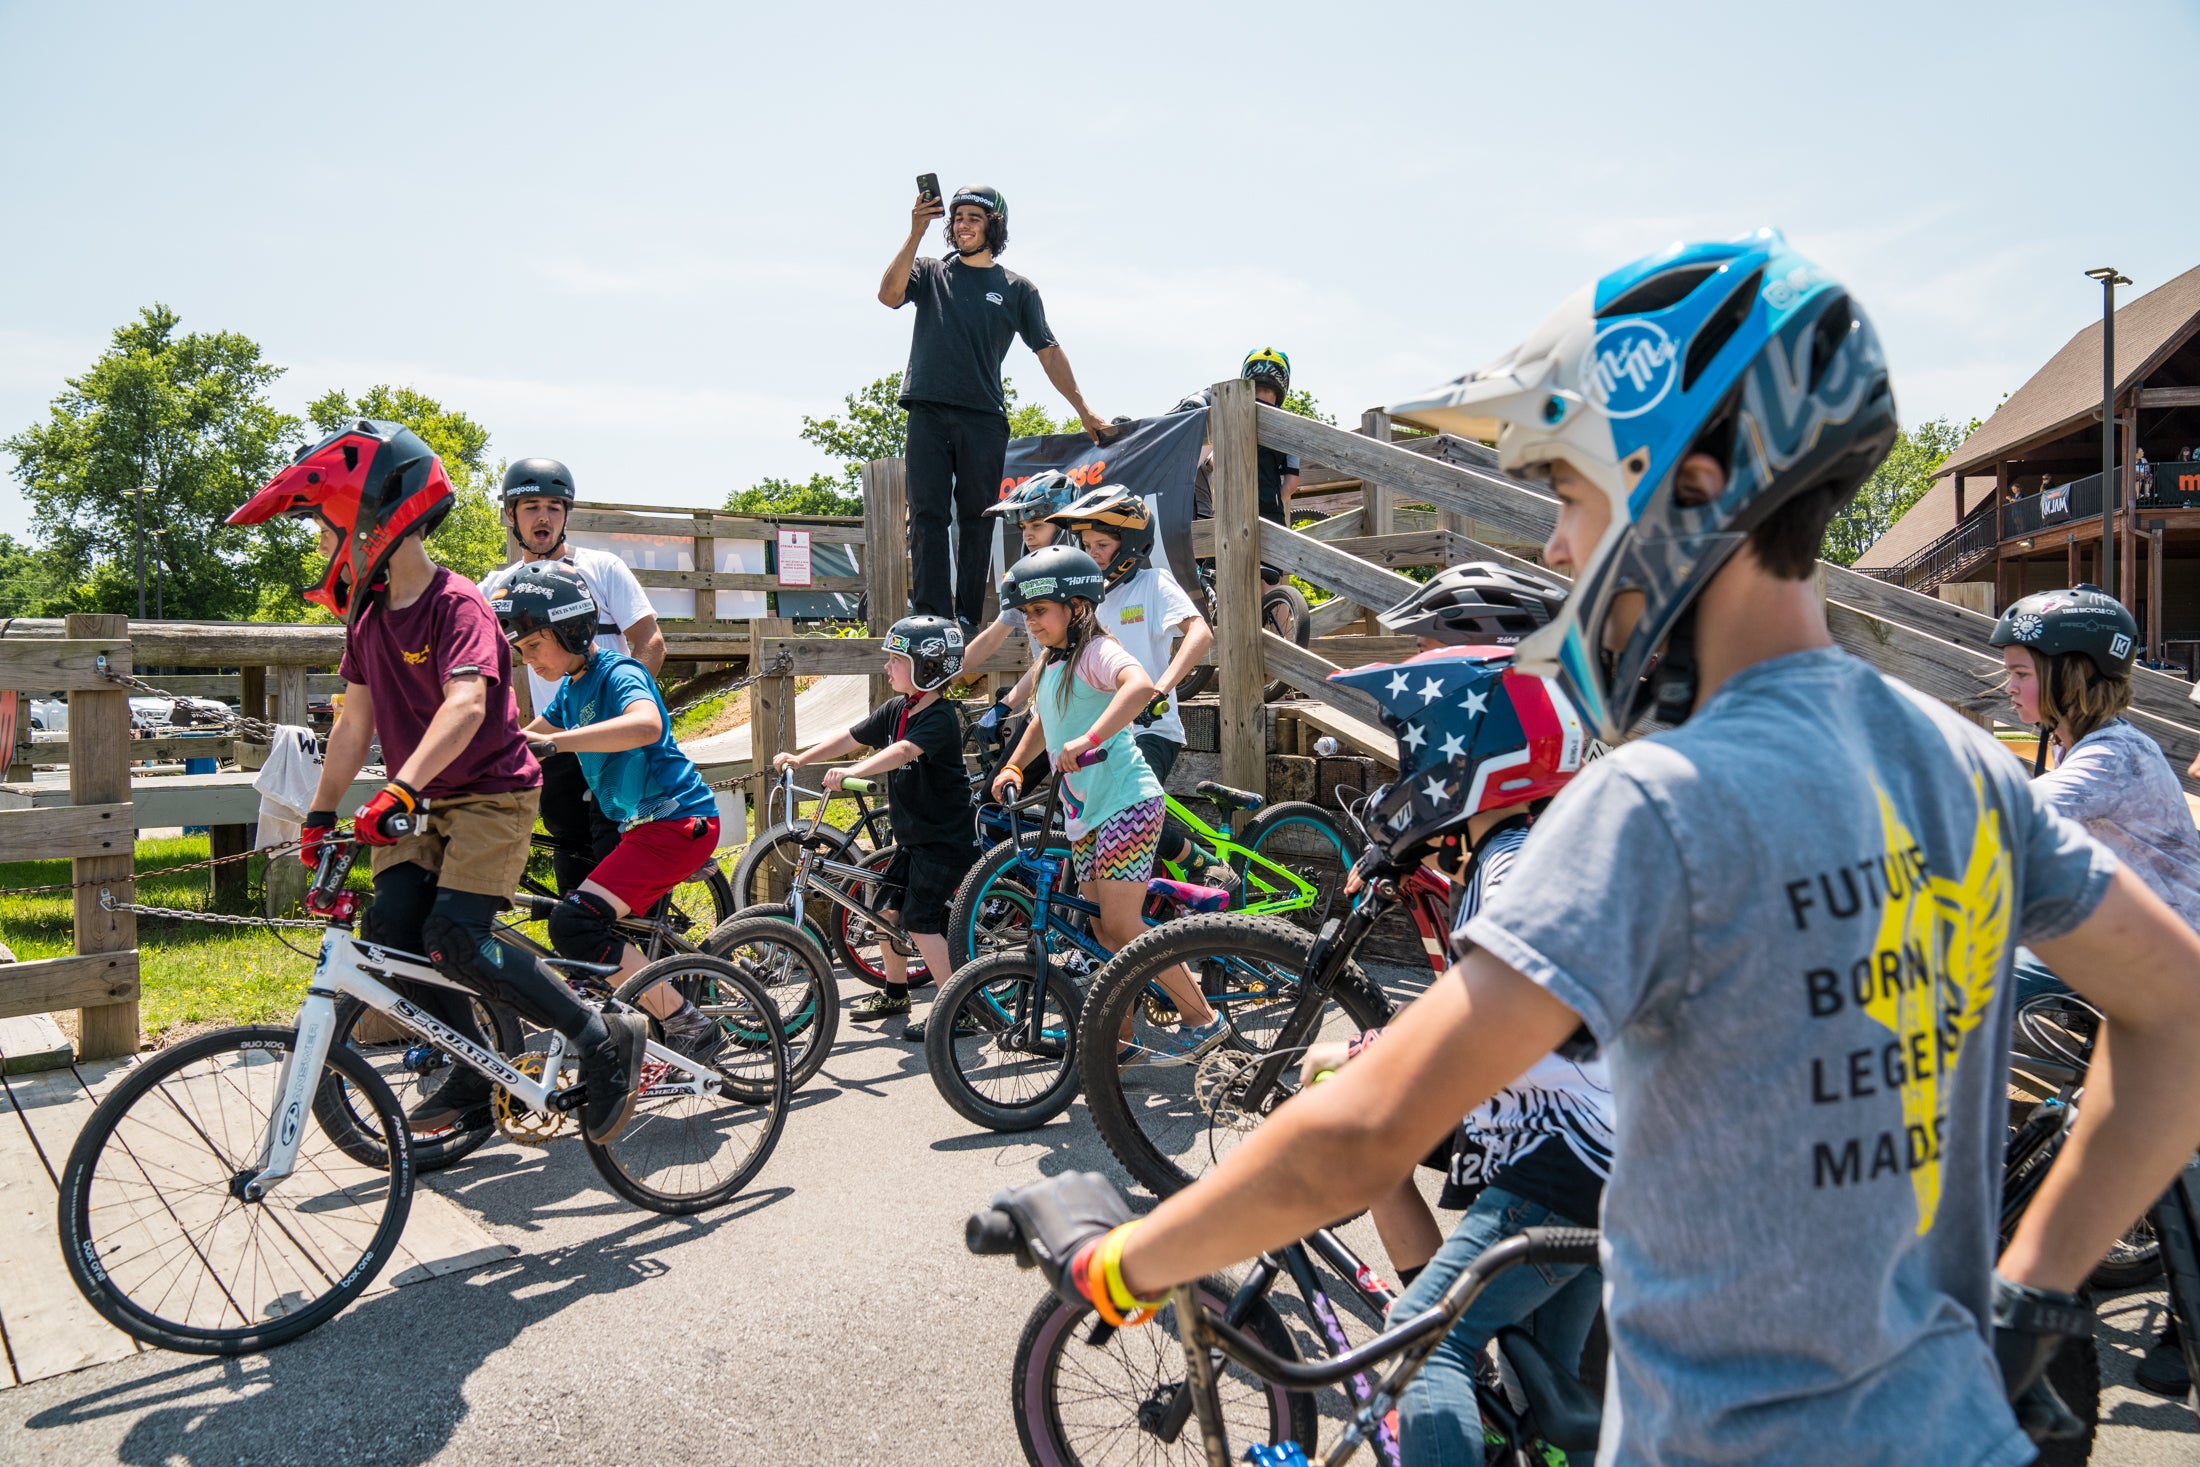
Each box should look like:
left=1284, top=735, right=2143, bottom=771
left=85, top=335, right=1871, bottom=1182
left=231, top=420, right=647, bottom=1141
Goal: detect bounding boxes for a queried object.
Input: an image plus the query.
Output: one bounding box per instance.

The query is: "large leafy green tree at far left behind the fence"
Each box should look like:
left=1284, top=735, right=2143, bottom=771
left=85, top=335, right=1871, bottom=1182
left=4, top=304, right=310, bottom=620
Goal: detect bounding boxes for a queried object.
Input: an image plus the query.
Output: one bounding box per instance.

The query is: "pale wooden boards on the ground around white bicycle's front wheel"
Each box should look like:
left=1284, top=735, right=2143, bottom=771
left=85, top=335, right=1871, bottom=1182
left=0, top=1033, right=515, bottom=1388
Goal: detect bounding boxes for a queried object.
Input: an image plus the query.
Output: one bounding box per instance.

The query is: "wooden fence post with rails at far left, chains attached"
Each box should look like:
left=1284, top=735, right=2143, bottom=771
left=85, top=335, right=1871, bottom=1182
left=0, top=616, right=139, bottom=1058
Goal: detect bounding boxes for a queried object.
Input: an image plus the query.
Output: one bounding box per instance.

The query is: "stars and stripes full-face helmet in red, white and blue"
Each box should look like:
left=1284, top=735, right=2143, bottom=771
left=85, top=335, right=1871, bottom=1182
left=1329, top=647, right=1604, bottom=864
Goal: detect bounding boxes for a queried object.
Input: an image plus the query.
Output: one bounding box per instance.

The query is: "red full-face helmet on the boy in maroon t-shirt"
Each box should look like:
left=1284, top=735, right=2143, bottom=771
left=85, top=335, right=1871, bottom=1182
left=229, top=418, right=455, bottom=625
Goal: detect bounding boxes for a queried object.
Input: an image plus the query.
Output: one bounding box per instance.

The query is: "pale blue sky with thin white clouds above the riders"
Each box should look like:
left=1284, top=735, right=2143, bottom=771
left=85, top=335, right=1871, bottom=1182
left=0, top=0, right=2200, bottom=545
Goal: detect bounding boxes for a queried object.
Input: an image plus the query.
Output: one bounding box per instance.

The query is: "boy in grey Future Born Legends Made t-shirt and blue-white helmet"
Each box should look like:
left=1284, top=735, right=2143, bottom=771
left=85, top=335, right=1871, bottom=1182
left=1003, top=231, right=2200, bottom=1467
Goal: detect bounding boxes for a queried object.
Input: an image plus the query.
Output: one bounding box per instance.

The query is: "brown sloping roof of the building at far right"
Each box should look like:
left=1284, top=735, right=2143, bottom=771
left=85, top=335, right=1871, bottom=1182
left=1944, top=266, right=2200, bottom=477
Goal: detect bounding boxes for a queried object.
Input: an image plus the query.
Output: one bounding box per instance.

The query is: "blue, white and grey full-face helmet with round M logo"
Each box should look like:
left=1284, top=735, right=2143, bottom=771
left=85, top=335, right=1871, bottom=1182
left=1388, top=229, right=1896, bottom=741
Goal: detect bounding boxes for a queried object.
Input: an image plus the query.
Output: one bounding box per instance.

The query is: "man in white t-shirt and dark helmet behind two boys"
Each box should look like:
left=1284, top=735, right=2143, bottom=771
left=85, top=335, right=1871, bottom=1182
left=482, top=457, right=664, bottom=895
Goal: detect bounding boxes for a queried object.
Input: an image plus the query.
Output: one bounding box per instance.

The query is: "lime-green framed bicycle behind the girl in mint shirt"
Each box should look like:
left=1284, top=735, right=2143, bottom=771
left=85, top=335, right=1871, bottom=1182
left=948, top=779, right=1362, bottom=970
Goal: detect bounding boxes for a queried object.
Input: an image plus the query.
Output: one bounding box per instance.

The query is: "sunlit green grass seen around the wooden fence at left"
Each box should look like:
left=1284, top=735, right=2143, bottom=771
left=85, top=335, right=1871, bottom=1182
left=0, top=836, right=367, bottom=1036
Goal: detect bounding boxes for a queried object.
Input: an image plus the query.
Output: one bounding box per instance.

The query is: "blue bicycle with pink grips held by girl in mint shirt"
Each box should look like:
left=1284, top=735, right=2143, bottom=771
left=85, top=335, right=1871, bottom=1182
left=924, top=750, right=1243, bottom=1130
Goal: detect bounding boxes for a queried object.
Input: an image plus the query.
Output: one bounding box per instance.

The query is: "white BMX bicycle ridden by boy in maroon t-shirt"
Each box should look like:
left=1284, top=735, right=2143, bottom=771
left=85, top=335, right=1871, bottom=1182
left=59, top=840, right=788, bottom=1355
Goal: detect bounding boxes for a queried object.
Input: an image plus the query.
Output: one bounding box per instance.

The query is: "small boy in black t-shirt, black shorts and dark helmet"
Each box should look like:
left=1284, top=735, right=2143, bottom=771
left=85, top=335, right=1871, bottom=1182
left=772, top=616, right=977, bottom=1043
